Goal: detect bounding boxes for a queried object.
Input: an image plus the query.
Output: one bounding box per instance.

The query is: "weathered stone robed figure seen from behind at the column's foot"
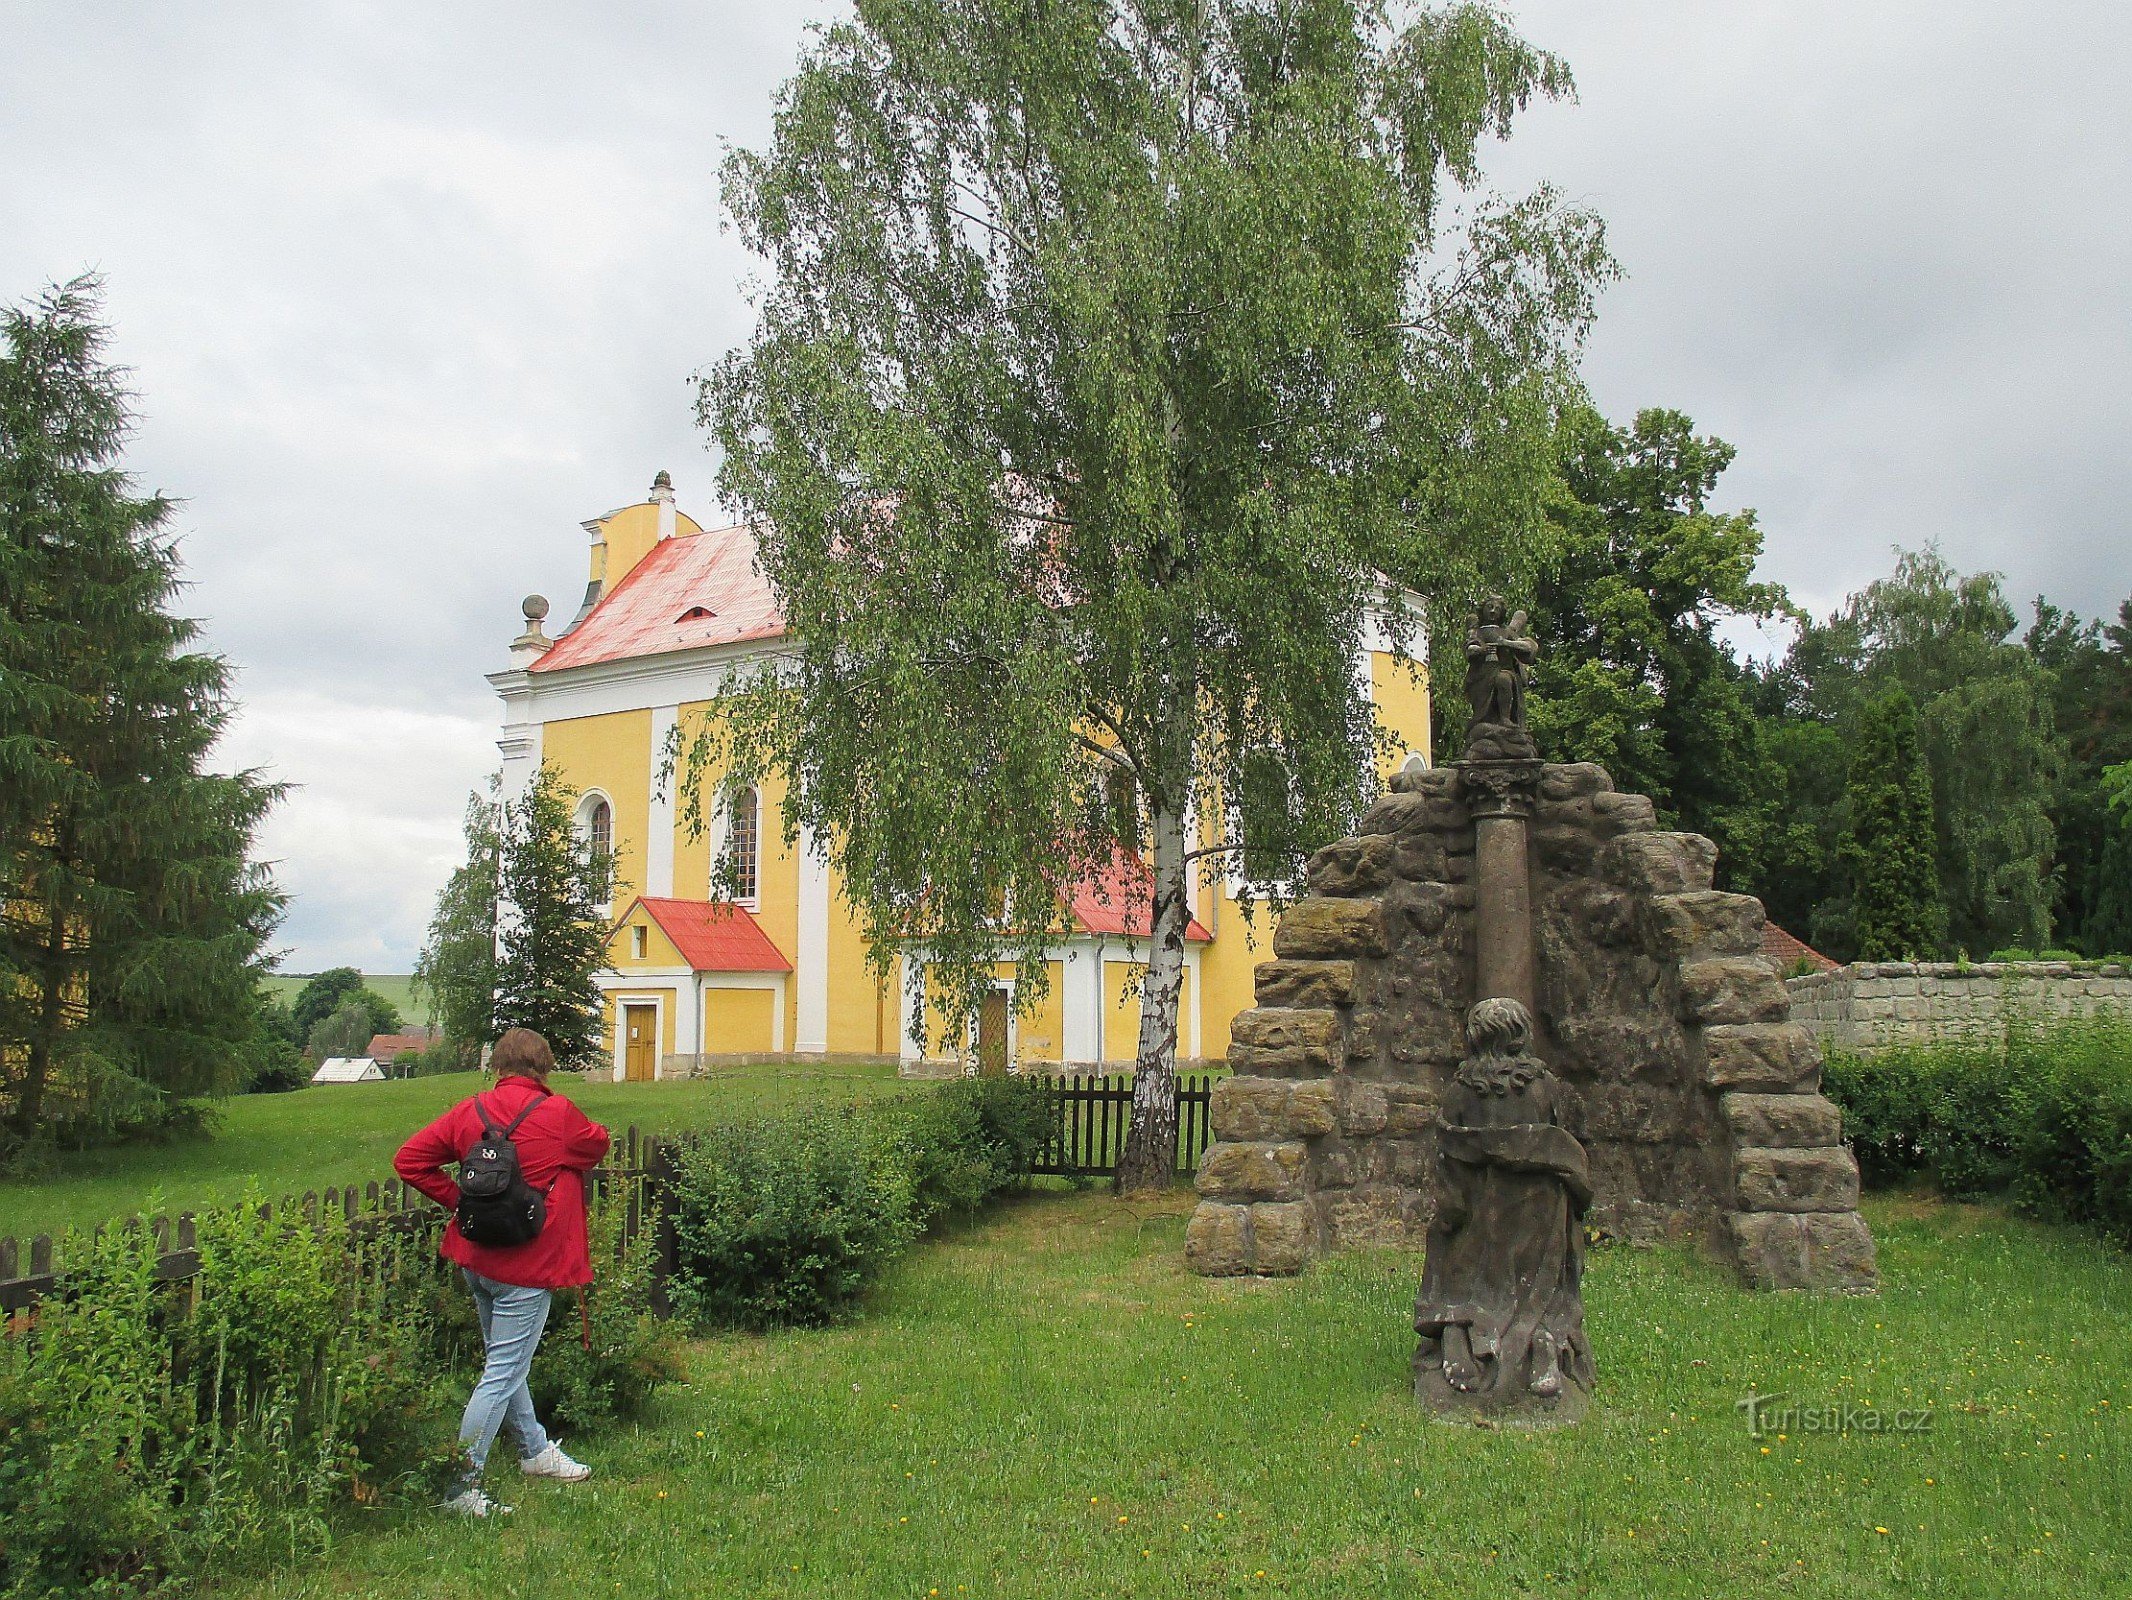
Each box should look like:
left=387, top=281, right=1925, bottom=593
left=1414, top=998, right=1593, bottom=1423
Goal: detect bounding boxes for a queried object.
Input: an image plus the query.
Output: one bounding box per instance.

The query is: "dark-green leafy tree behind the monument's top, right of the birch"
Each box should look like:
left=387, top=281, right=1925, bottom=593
left=1531, top=407, right=1791, bottom=887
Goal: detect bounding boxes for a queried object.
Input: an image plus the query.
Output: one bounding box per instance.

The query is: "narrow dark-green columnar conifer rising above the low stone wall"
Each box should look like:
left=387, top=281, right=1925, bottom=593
left=1844, top=685, right=1947, bottom=962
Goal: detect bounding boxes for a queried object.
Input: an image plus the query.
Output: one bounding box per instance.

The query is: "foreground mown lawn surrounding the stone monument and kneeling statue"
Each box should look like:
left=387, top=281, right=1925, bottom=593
left=203, top=1193, right=2132, bottom=1600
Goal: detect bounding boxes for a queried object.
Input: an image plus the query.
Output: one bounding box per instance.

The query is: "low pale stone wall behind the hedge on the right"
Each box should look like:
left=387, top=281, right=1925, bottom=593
left=1784, top=962, right=2132, bottom=1050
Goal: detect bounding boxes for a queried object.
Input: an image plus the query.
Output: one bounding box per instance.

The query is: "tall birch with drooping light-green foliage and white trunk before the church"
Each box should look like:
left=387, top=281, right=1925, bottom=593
left=687, top=0, right=1610, bottom=1184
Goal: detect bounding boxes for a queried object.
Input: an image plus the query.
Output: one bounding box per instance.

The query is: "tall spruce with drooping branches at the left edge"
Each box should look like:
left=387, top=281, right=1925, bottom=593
left=0, top=277, right=281, bottom=1143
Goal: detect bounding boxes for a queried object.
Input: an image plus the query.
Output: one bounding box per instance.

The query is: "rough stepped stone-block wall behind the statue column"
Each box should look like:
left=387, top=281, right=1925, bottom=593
left=1185, top=766, right=1872, bottom=1289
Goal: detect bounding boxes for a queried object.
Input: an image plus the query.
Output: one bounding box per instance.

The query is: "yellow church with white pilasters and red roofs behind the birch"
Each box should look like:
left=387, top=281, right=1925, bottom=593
left=488, top=471, right=1431, bottom=1082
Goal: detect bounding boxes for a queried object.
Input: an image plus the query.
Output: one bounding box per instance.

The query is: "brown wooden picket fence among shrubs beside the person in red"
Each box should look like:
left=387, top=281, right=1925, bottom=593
left=0, top=1126, right=674, bottom=1333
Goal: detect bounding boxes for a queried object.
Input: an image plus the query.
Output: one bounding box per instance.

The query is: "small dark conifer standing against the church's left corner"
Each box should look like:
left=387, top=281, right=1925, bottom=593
left=495, top=766, right=608, bottom=1067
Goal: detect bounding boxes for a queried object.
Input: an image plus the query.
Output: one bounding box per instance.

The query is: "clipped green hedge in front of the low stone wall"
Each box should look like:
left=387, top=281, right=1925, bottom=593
left=1823, top=1015, right=2132, bottom=1246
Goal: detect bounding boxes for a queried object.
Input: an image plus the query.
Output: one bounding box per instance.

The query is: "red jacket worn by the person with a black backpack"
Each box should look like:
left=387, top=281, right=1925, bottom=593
left=392, top=1073, right=608, bottom=1289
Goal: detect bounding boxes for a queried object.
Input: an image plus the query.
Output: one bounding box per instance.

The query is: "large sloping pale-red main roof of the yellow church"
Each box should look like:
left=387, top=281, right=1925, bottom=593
left=531, top=527, right=785, bottom=672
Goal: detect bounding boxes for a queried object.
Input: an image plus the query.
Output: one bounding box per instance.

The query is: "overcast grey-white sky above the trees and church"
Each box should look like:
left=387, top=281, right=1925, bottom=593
left=0, top=0, right=2132, bottom=973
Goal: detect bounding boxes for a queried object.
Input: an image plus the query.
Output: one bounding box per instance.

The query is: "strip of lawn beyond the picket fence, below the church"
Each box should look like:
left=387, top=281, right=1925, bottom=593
left=0, top=1062, right=898, bottom=1237
